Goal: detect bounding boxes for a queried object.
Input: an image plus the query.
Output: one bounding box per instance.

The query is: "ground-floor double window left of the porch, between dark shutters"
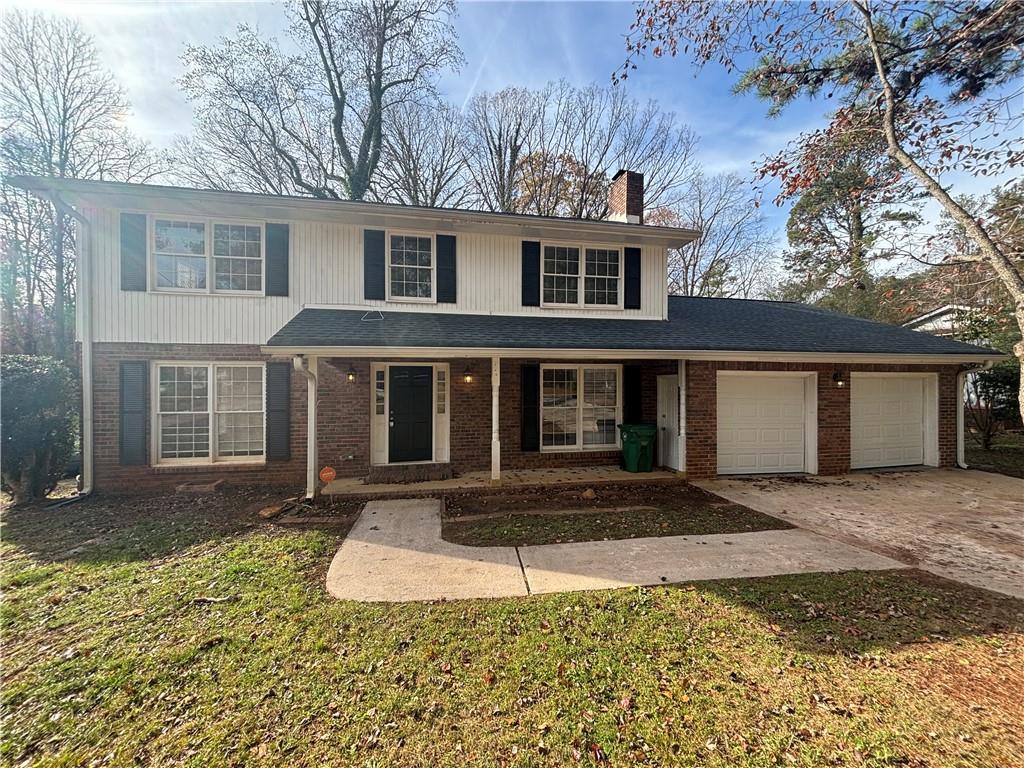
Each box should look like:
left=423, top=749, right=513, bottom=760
left=154, top=362, right=266, bottom=464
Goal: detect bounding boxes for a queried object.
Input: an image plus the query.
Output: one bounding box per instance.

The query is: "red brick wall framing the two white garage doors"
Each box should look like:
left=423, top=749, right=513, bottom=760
left=686, top=360, right=958, bottom=479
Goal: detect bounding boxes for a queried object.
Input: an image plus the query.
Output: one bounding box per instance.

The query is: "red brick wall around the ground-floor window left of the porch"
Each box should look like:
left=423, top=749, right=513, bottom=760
left=92, top=343, right=306, bottom=493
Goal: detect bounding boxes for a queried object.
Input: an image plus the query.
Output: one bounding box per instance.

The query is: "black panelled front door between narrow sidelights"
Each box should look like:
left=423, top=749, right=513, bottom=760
left=387, top=366, right=434, bottom=464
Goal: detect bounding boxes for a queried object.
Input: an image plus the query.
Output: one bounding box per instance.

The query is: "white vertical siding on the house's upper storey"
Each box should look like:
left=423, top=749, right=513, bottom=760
left=77, top=208, right=668, bottom=344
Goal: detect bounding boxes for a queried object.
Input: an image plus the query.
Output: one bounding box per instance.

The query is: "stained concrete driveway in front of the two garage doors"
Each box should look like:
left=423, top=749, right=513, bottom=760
left=695, top=469, right=1024, bottom=598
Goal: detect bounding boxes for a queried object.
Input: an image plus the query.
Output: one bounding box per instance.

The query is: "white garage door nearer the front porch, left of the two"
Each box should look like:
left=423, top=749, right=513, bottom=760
left=718, top=375, right=806, bottom=474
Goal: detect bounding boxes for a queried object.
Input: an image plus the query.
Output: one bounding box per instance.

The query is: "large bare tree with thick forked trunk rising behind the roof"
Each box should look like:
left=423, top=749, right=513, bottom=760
left=181, top=0, right=462, bottom=200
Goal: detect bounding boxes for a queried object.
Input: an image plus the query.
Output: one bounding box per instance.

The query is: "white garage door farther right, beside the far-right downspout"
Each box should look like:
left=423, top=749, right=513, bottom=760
left=850, top=375, right=925, bottom=469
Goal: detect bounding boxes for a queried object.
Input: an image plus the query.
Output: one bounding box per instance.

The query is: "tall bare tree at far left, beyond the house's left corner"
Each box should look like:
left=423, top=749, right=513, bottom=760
left=0, top=11, right=163, bottom=359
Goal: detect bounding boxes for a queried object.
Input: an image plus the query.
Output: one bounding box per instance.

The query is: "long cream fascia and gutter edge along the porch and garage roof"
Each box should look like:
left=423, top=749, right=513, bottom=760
left=260, top=345, right=1007, bottom=366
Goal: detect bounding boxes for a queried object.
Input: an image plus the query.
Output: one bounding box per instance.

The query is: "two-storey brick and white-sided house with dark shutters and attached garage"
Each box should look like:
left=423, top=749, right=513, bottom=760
left=13, top=172, right=998, bottom=493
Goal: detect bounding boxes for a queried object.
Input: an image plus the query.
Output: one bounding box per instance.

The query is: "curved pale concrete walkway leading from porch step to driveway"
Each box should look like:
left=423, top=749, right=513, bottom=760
left=327, top=499, right=904, bottom=602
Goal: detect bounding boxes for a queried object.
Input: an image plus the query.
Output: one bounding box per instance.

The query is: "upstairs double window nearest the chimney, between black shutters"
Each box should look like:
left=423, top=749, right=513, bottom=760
left=543, top=244, right=622, bottom=307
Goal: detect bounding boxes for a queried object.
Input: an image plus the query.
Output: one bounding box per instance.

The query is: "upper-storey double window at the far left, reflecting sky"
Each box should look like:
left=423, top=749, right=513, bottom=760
left=152, top=216, right=265, bottom=293
